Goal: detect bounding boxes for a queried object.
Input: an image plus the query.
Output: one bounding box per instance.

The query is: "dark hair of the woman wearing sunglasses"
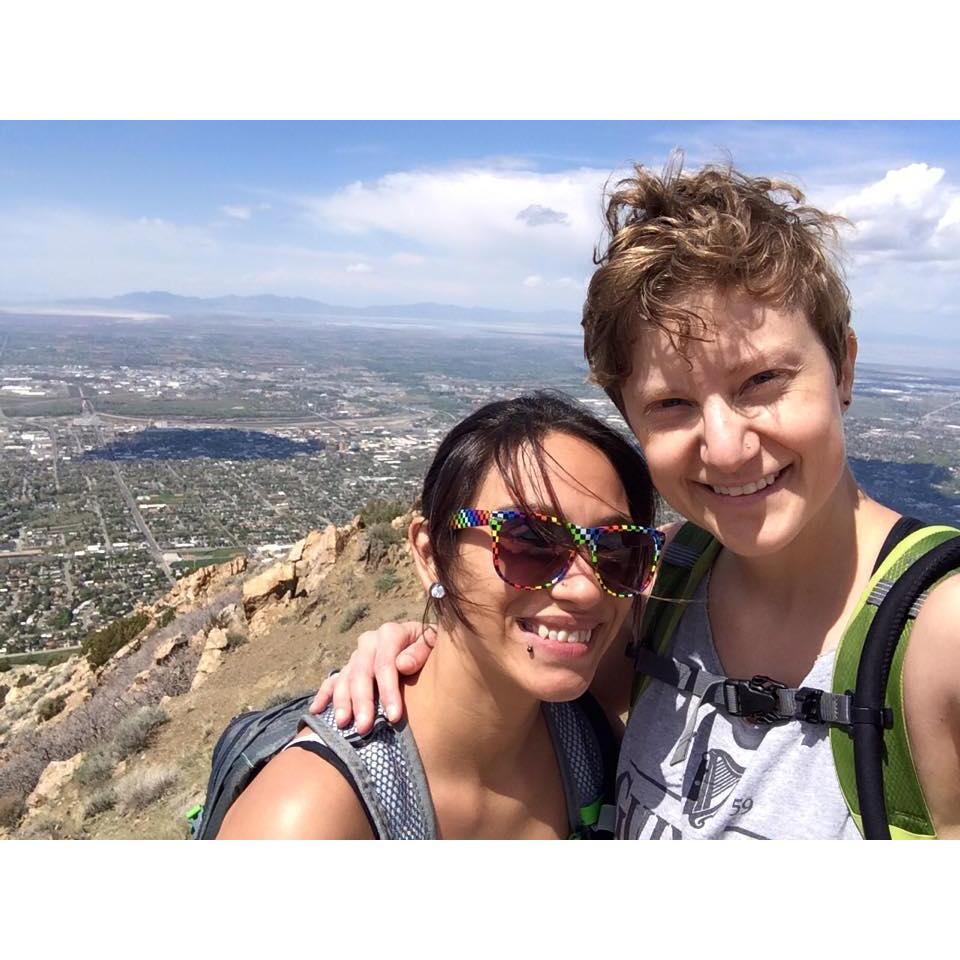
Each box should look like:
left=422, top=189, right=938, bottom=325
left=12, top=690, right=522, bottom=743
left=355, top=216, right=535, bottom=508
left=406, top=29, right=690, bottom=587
left=420, top=391, right=657, bottom=625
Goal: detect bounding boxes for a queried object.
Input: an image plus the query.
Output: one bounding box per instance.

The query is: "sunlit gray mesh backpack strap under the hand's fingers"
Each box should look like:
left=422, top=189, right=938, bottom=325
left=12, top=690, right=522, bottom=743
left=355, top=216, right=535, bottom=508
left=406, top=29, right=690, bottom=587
left=303, top=707, right=437, bottom=840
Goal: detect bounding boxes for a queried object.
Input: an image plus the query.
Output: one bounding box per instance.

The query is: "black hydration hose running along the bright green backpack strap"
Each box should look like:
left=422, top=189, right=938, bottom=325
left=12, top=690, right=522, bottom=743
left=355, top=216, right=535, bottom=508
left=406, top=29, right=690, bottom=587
left=853, top=537, right=960, bottom=840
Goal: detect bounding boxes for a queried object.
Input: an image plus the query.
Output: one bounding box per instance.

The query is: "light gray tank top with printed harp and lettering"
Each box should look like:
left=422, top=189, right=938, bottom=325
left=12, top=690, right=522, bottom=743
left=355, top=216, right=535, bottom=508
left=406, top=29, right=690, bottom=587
left=616, top=574, right=860, bottom=840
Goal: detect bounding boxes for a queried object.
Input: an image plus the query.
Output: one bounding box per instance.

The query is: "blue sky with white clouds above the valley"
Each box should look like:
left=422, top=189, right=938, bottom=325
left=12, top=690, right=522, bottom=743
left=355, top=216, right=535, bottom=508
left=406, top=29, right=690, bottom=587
left=0, top=121, right=960, bottom=364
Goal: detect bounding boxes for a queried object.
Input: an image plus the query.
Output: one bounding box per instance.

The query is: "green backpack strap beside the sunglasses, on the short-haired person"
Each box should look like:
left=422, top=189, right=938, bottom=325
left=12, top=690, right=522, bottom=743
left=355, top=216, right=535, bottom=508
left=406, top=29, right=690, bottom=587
left=628, top=522, right=720, bottom=709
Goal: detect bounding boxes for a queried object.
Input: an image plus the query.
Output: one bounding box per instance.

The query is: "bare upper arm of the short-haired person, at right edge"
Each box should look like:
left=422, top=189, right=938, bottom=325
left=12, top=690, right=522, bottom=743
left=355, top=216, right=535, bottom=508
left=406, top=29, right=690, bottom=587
left=903, top=575, right=960, bottom=837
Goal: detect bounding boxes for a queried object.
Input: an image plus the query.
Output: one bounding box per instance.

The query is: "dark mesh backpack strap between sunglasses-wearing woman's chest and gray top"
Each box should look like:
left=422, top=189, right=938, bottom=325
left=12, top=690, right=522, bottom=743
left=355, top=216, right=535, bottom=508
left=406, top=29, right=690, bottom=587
left=542, top=694, right=617, bottom=839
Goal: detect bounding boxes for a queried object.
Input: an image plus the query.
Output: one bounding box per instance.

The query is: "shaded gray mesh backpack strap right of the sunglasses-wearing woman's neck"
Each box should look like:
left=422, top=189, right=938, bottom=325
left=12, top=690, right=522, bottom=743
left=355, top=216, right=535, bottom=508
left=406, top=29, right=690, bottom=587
left=542, top=702, right=604, bottom=835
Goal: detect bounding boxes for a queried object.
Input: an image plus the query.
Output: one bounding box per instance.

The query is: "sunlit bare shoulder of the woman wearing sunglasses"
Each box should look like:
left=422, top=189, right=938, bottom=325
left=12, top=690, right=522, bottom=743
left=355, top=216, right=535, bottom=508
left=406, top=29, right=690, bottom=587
left=217, top=748, right=373, bottom=840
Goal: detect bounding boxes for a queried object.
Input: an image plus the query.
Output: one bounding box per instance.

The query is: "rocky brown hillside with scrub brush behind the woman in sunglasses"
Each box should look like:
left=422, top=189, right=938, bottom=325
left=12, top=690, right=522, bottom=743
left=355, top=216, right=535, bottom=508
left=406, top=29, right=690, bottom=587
left=0, top=517, right=423, bottom=838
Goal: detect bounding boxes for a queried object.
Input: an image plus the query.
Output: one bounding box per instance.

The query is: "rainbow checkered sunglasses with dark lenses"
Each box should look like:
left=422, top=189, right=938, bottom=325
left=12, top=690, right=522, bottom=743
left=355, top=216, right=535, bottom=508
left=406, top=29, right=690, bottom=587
left=450, top=507, right=665, bottom=597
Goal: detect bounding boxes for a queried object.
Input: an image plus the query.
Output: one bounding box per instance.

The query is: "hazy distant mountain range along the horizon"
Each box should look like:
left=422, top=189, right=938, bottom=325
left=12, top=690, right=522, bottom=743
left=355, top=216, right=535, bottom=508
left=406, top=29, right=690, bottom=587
left=30, top=290, right=580, bottom=327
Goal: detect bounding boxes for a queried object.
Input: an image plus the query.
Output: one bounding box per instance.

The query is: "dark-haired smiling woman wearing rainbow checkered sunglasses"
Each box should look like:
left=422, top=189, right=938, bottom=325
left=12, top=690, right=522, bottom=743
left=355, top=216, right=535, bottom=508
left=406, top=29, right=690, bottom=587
left=219, top=393, right=662, bottom=839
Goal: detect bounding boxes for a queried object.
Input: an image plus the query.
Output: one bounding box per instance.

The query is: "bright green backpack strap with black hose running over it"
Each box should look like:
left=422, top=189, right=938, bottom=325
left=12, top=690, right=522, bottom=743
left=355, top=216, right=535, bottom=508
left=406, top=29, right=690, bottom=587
left=830, top=524, right=960, bottom=839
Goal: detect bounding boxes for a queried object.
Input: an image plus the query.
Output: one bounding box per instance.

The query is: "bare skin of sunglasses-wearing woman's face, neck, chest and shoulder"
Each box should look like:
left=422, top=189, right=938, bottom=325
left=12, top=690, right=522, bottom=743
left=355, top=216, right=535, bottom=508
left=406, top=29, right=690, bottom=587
left=220, top=433, right=632, bottom=839
